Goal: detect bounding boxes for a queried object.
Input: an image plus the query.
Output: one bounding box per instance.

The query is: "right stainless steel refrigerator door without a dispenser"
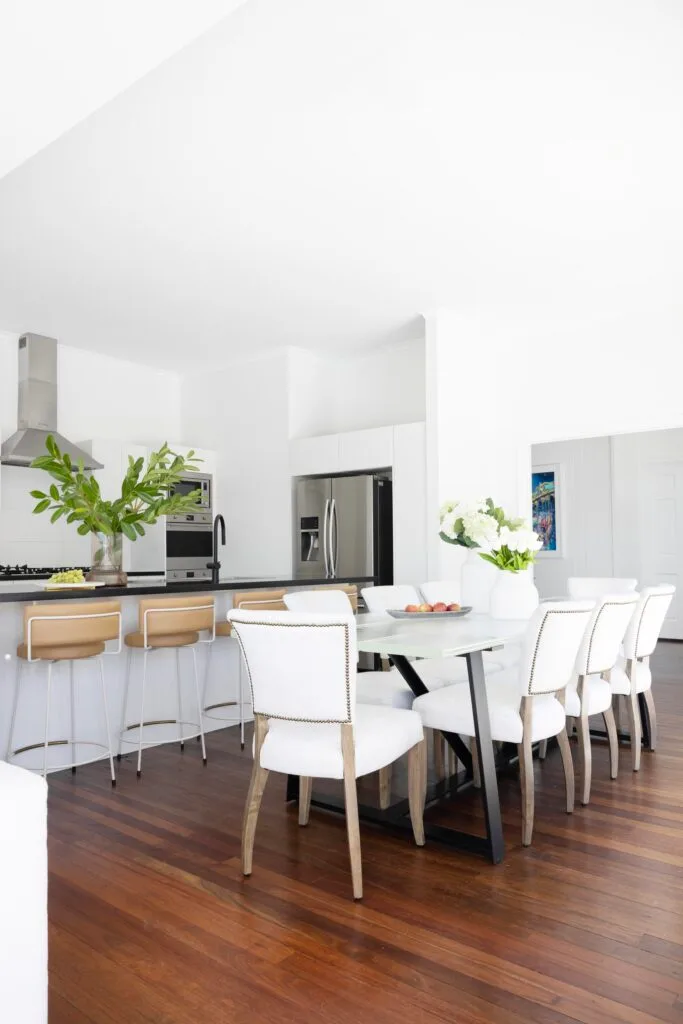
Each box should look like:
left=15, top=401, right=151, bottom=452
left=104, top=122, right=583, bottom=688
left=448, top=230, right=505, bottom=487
left=328, top=474, right=375, bottom=578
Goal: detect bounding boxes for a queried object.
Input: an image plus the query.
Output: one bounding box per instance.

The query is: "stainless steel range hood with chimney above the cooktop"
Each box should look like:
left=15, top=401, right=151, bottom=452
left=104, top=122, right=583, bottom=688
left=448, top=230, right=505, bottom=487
left=0, top=334, right=102, bottom=469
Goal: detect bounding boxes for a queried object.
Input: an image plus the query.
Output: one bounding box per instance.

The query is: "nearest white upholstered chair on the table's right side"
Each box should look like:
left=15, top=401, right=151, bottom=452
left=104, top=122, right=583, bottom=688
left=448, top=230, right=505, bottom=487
left=413, top=601, right=593, bottom=846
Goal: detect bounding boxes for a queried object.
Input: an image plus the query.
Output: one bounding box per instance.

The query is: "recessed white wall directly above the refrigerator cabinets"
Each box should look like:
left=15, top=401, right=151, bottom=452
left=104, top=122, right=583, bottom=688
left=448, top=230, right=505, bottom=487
left=289, top=338, right=425, bottom=437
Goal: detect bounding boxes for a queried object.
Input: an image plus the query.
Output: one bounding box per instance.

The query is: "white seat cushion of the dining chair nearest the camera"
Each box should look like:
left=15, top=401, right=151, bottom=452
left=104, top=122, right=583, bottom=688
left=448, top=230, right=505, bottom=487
left=261, top=705, right=423, bottom=778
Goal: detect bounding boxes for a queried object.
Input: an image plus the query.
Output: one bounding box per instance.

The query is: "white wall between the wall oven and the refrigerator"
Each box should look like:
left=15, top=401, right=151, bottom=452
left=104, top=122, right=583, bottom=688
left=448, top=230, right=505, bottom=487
left=181, top=351, right=292, bottom=577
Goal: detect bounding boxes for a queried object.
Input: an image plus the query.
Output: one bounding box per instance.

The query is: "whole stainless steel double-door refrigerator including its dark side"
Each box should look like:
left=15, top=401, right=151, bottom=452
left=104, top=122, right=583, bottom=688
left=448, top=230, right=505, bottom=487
left=294, top=472, right=393, bottom=584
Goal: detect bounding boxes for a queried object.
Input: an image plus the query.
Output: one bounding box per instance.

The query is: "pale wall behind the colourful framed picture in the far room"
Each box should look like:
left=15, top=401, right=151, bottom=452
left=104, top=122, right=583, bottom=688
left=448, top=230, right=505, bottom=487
left=529, top=437, right=614, bottom=598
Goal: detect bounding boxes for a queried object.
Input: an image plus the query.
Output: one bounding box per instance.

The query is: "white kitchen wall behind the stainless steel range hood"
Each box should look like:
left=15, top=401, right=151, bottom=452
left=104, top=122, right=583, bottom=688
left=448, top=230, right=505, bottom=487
left=0, top=332, right=180, bottom=565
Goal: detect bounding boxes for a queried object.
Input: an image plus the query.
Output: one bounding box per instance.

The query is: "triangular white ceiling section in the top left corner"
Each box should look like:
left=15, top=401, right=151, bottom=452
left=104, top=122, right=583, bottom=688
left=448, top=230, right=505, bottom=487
left=0, top=0, right=244, bottom=177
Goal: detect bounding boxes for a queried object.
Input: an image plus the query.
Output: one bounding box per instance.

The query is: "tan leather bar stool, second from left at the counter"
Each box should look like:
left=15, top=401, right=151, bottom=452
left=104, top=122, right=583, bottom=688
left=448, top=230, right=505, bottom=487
left=117, top=594, right=216, bottom=778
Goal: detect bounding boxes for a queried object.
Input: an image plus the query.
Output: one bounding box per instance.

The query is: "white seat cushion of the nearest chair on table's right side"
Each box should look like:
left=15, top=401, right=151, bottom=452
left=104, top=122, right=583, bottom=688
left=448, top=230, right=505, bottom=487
left=413, top=677, right=566, bottom=743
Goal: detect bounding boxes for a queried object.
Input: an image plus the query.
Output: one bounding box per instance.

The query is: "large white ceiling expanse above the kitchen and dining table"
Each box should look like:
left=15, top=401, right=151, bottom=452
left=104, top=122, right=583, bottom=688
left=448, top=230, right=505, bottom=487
left=0, top=0, right=683, bottom=374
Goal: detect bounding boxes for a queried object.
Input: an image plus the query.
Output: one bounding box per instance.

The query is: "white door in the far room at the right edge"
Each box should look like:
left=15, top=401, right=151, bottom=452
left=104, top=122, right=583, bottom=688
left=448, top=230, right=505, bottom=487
left=639, top=460, right=683, bottom=640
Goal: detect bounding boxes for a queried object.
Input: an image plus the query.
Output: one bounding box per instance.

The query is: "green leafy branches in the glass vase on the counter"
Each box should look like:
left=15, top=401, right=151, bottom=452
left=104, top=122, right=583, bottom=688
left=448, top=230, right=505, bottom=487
left=31, top=434, right=202, bottom=541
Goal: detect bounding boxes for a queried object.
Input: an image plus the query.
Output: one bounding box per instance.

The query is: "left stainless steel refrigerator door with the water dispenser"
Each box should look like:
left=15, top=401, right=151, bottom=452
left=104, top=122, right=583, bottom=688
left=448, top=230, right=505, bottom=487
left=293, top=477, right=332, bottom=580
